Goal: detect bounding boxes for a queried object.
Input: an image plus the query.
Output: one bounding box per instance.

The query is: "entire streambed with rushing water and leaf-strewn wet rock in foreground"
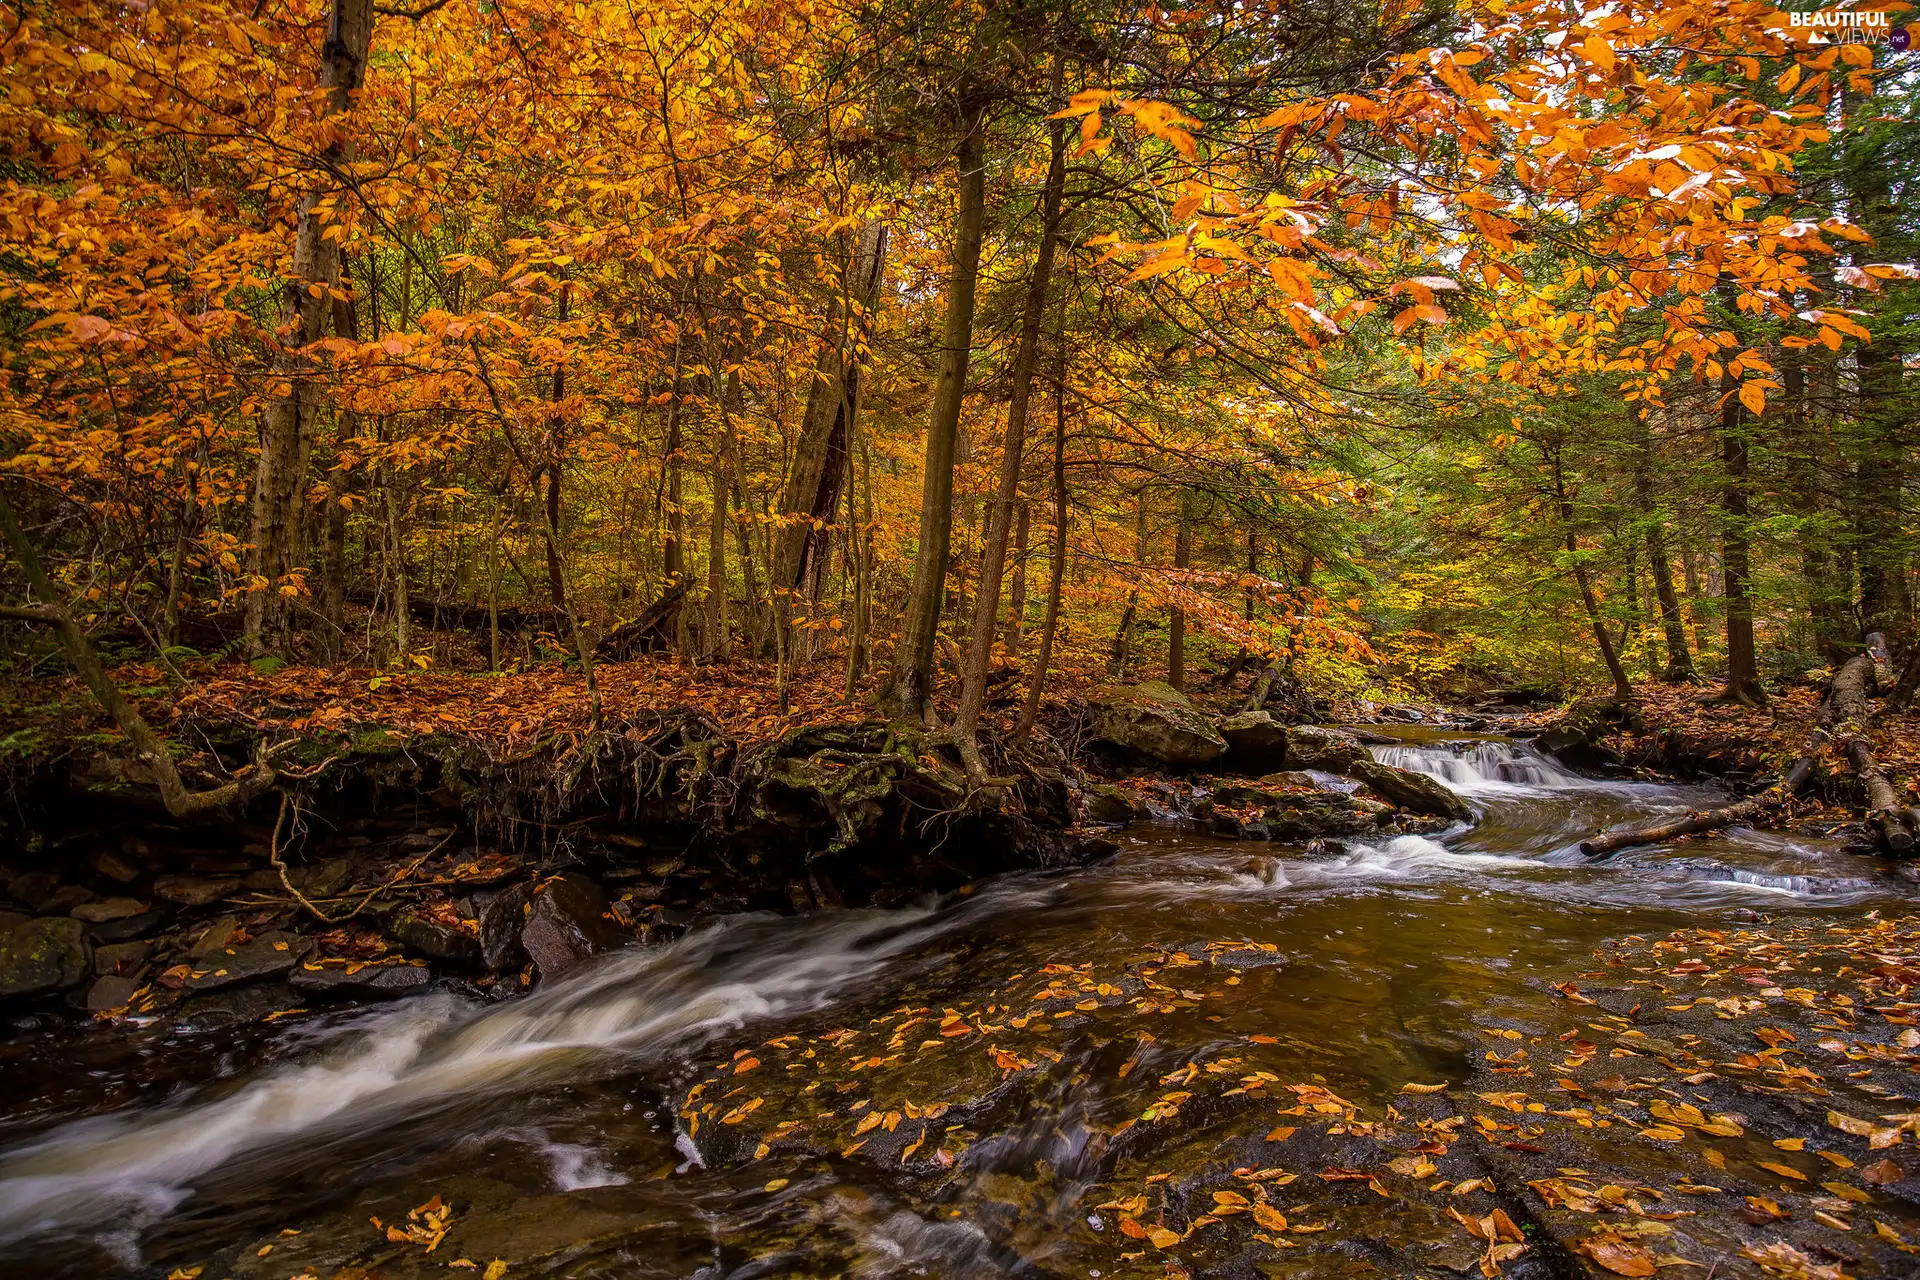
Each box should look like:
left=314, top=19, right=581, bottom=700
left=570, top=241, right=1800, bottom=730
left=0, top=731, right=1920, bottom=1280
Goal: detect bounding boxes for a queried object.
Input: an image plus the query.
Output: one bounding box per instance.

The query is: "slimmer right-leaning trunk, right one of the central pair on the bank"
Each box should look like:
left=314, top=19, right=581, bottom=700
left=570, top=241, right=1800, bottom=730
left=954, top=110, right=1068, bottom=752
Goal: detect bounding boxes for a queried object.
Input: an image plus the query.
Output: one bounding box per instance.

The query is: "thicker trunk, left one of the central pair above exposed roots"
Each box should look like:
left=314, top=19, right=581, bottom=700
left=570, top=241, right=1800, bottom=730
left=881, top=107, right=987, bottom=720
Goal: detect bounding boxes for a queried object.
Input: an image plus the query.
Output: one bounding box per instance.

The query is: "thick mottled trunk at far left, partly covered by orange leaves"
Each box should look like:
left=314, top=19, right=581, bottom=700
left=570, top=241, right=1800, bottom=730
left=246, top=0, right=372, bottom=654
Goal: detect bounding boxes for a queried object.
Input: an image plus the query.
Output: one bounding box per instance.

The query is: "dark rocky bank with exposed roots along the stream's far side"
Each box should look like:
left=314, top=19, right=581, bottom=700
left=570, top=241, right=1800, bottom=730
left=0, top=683, right=1512, bottom=1032
